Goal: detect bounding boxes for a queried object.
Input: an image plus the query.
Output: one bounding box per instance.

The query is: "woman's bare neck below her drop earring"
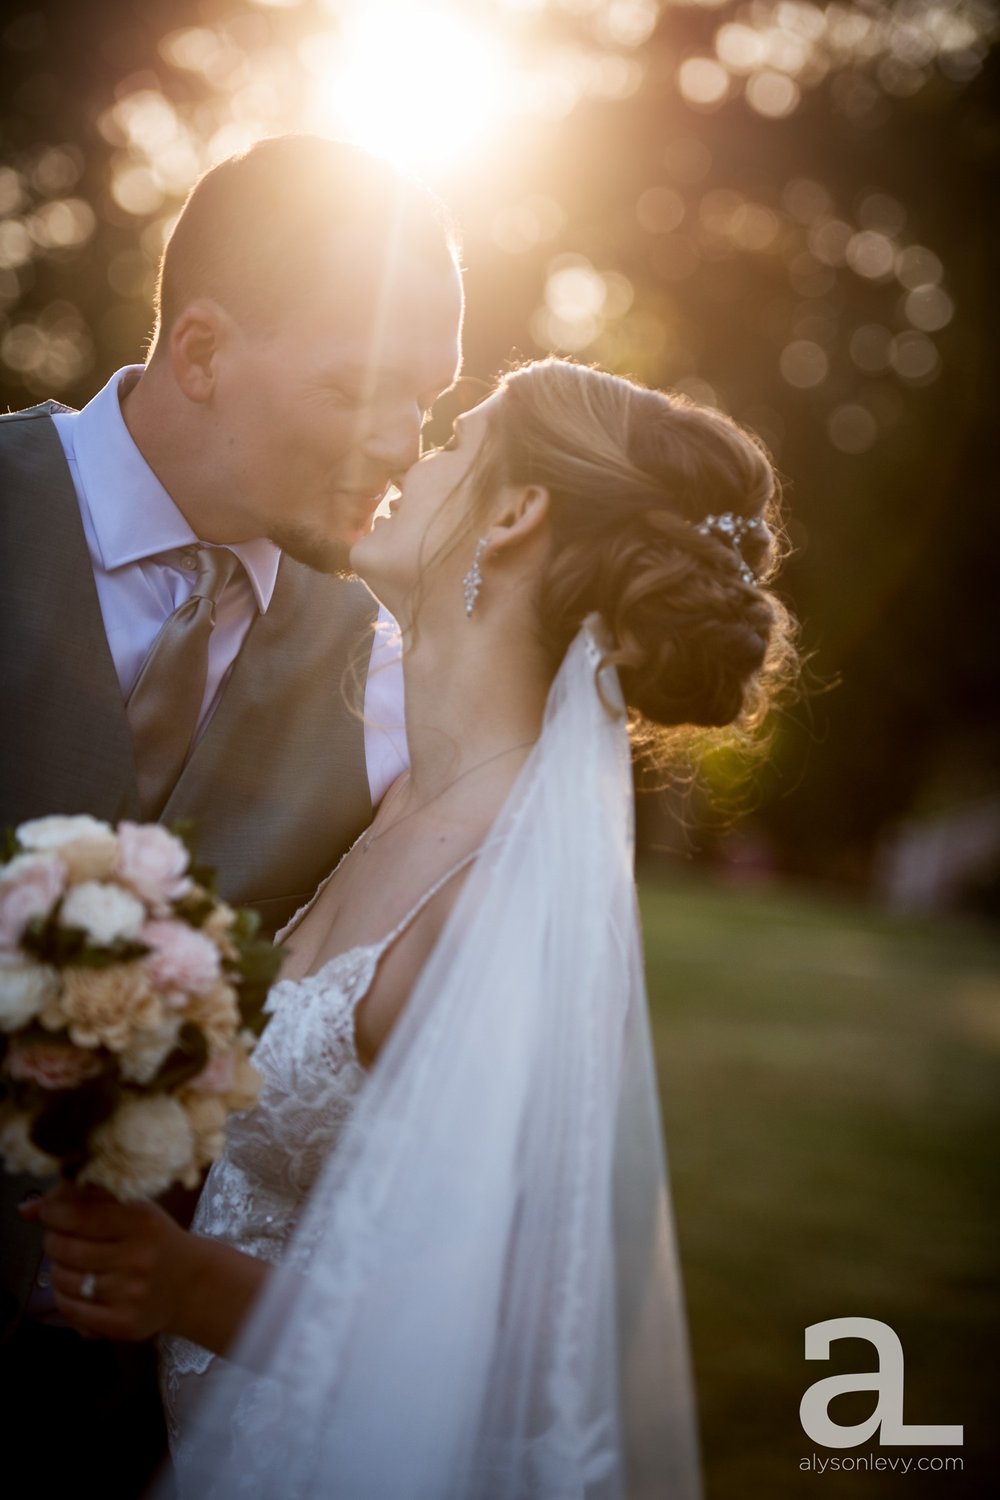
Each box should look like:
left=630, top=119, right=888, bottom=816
left=403, top=626, right=549, bottom=797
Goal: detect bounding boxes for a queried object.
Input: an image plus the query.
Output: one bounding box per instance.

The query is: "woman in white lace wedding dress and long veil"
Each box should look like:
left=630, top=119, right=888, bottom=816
left=29, top=360, right=793, bottom=1500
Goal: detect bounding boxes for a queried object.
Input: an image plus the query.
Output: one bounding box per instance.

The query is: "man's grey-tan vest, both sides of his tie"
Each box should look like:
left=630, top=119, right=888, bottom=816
left=0, top=402, right=375, bottom=1335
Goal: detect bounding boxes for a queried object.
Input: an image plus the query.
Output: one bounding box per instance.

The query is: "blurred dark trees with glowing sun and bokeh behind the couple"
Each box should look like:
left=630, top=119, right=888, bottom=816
left=0, top=0, right=1000, bottom=914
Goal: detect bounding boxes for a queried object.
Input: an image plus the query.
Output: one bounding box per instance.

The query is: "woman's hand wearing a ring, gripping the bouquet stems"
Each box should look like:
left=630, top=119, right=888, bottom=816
left=22, top=1184, right=198, bottom=1340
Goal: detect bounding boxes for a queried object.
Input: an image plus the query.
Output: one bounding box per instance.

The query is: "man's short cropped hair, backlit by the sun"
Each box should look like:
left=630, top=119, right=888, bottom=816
left=153, top=135, right=459, bottom=345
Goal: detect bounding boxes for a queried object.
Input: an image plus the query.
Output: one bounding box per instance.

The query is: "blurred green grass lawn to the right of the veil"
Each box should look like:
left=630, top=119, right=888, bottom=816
left=640, top=873, right=1000, bottom=1500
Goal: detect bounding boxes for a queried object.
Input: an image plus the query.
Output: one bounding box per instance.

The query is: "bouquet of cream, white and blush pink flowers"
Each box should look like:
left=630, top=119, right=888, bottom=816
left=0, top=816, right=280, bottom=1200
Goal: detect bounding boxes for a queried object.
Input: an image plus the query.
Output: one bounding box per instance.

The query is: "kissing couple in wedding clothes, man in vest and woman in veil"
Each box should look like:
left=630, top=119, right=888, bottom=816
left=0, top=137, right=792, bottom=1500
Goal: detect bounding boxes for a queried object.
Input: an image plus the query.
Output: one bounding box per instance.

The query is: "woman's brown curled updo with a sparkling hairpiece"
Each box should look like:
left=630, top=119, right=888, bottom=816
left=458, top=359, right=798, bottom=759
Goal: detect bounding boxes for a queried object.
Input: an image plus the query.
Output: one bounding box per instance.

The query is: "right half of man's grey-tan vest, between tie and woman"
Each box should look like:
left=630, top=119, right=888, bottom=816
left=162, top=557, right=376, bottom=927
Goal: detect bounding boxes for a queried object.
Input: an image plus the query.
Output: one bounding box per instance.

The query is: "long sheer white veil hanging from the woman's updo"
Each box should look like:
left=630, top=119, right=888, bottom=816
left=177, top=617, right=702, bottom=1500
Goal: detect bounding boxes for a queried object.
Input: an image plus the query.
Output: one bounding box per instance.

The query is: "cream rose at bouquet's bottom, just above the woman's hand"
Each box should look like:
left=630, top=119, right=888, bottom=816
left=78, top=1094, right=195, bottom=1203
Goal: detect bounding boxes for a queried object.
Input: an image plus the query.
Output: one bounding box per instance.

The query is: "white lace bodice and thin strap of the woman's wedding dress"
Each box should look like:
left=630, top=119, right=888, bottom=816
left=160, top=854, right=475, bottom=1440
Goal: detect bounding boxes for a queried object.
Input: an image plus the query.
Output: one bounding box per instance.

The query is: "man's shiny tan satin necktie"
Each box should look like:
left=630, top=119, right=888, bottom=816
left=124, top=548, right=240, bottom=819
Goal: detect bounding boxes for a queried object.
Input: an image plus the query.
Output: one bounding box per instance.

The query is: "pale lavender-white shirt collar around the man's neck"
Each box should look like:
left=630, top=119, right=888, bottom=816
left=73, top=365, right=282, bottom=614
